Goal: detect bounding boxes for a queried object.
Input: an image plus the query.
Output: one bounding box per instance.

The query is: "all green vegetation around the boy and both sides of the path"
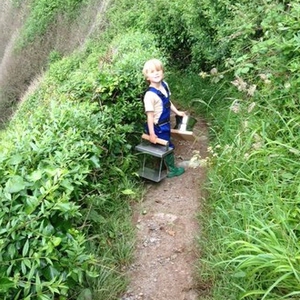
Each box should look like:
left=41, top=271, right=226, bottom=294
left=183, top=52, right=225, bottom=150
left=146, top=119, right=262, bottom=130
left=0, top=0, right=300, bottom=300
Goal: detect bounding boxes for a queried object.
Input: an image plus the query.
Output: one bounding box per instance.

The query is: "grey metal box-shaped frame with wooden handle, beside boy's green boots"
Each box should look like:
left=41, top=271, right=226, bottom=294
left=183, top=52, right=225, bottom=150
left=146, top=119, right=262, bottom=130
left=135, top=134, right=173, bottom=182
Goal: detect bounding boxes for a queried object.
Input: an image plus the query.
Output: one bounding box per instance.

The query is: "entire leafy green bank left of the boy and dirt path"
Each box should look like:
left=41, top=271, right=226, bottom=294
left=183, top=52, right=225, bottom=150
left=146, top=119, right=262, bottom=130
left=0, top=29, right=164, bottom=299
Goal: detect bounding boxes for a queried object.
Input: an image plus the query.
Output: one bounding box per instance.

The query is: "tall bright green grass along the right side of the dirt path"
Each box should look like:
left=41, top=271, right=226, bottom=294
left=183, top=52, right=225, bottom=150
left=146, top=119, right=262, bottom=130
left=200, top=83, right=300, bottom=299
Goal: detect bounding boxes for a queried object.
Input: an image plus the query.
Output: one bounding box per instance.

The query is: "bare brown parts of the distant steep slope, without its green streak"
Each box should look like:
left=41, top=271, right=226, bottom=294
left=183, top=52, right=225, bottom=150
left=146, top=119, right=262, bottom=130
left=0, top=0, right=110, bottom=123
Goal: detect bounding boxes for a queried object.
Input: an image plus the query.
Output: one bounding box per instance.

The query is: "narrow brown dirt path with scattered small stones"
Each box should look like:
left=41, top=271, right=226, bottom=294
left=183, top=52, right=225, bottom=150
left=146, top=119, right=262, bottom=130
left=121, top=119, right=207, bottom=300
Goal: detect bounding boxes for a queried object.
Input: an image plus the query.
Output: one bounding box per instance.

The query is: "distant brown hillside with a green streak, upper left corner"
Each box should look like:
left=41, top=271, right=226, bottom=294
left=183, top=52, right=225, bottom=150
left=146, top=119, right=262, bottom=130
left=0, top=0, right=109, bottom=127
